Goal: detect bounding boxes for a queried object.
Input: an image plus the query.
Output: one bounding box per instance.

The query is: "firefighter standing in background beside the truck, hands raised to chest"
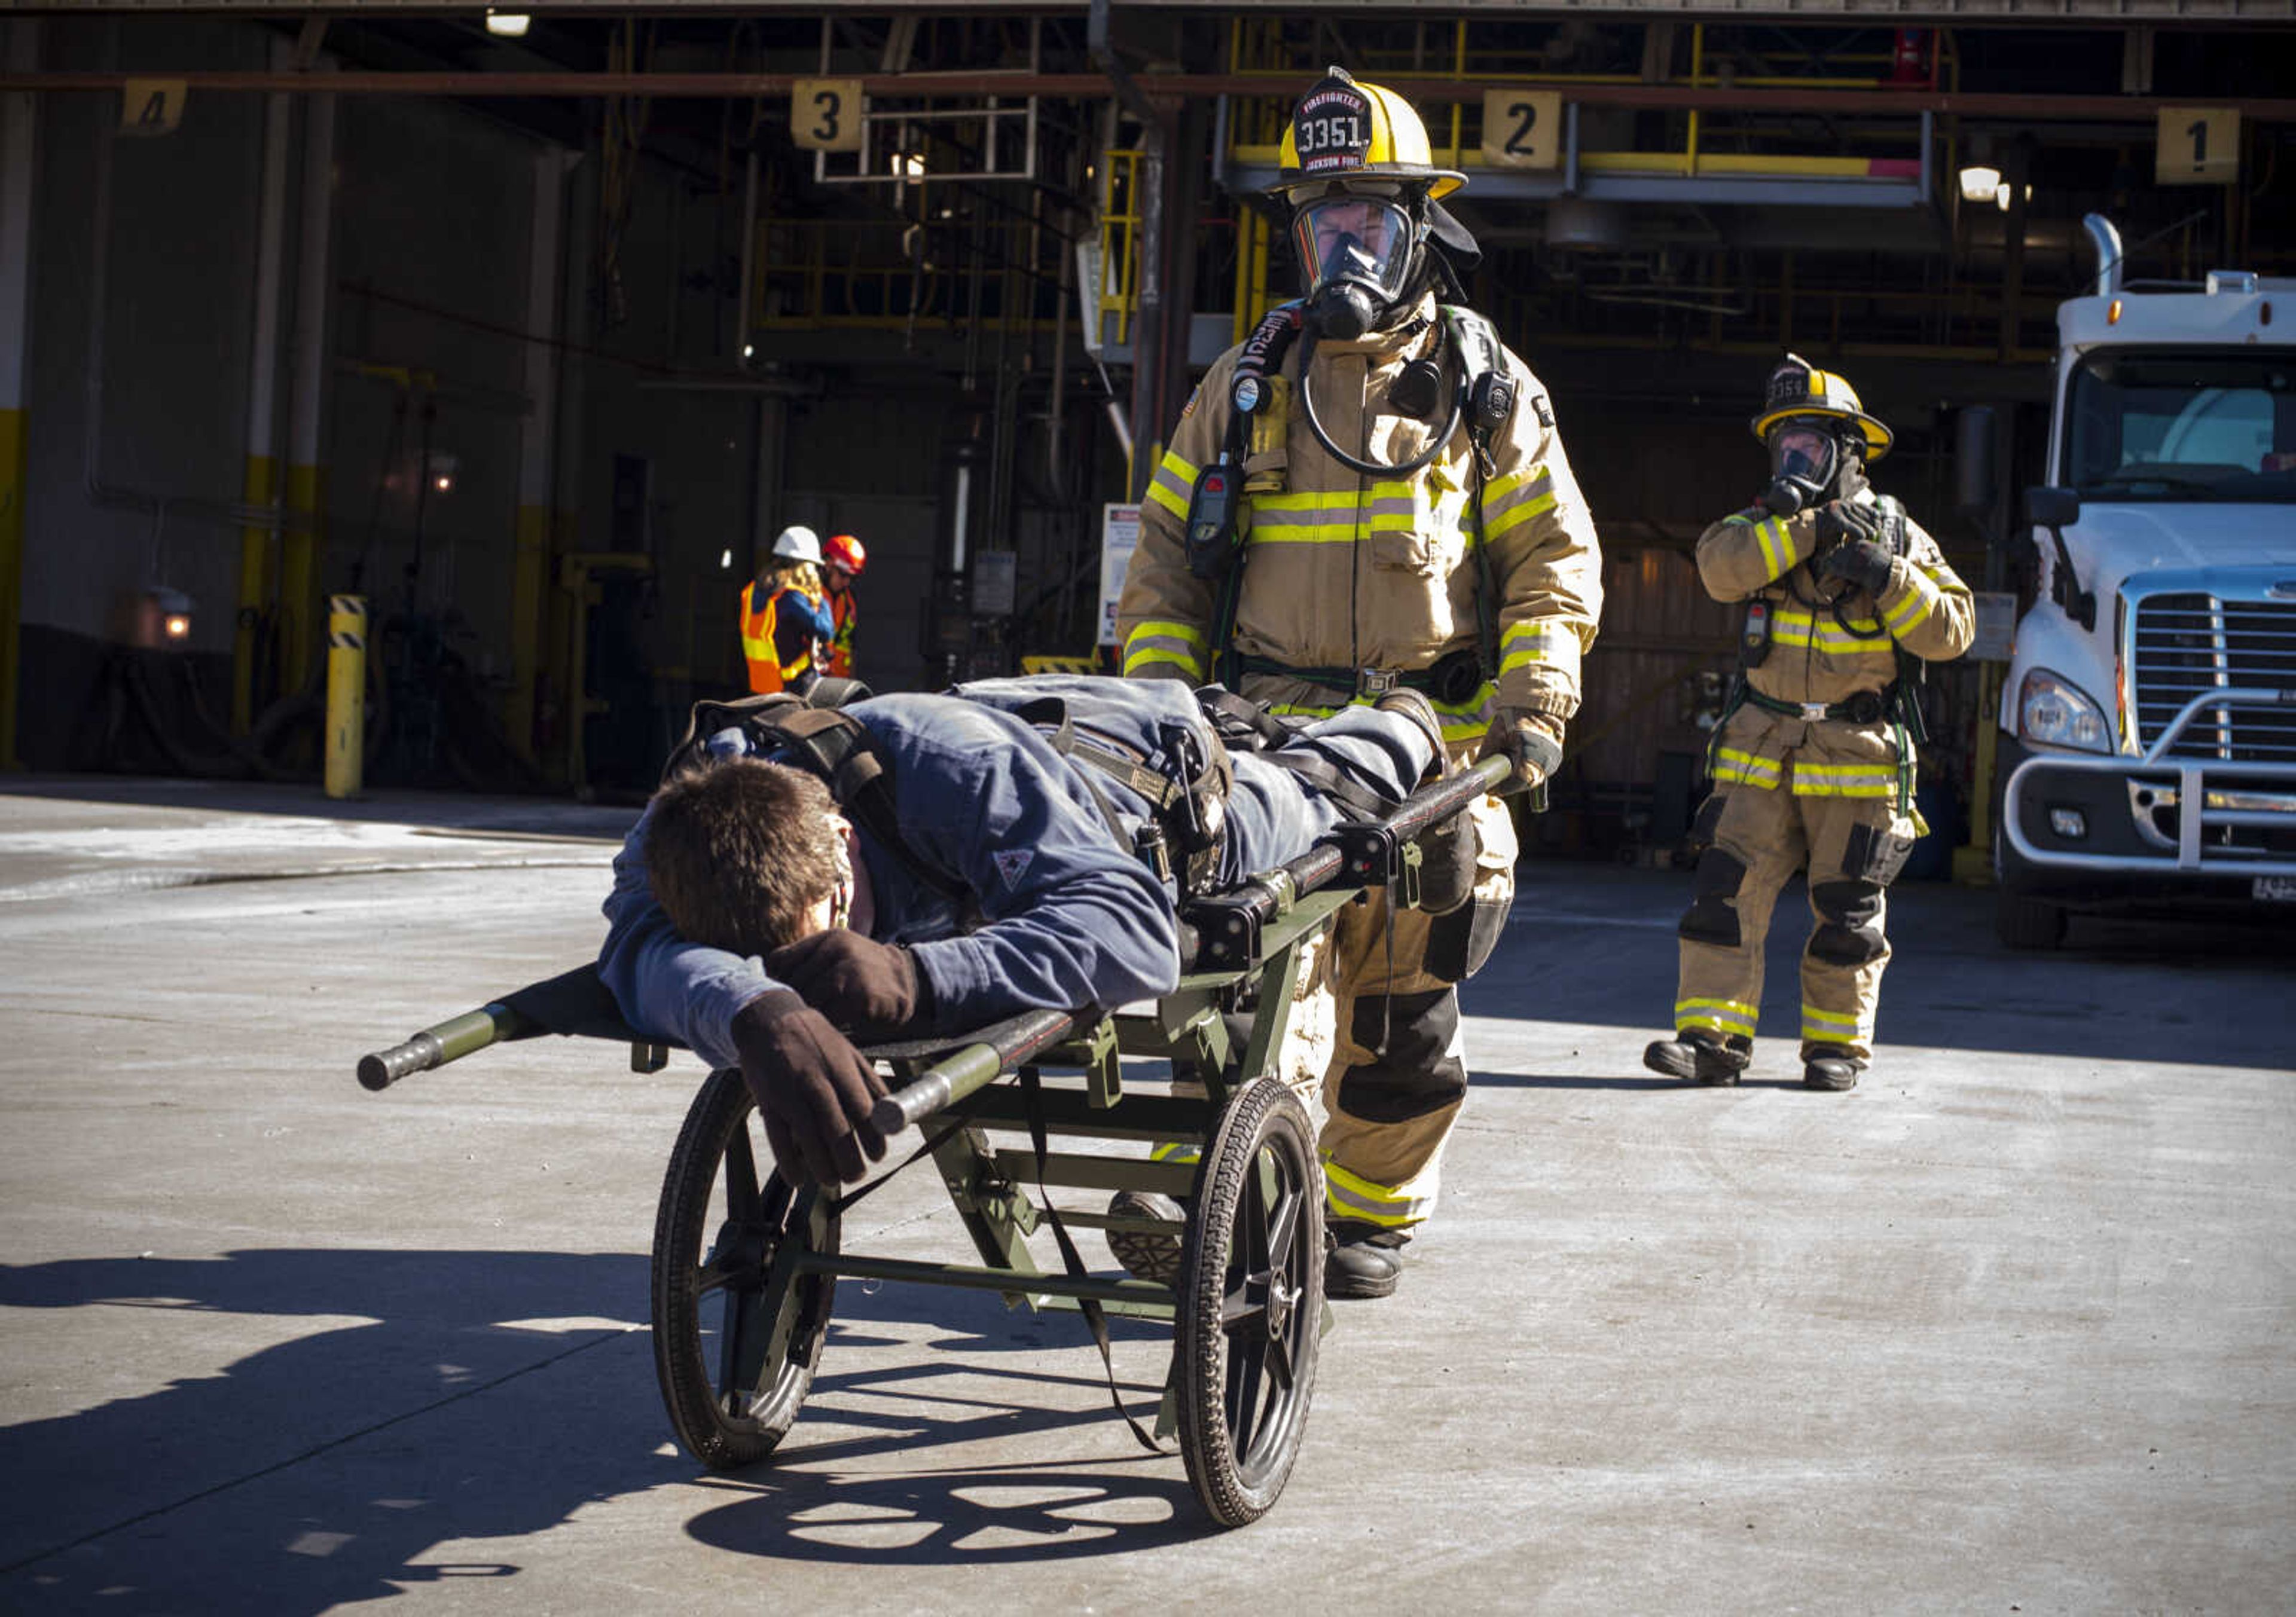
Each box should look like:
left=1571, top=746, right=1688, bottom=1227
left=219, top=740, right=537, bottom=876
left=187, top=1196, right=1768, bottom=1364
left=1642, top=354, right=1974, bottom=1089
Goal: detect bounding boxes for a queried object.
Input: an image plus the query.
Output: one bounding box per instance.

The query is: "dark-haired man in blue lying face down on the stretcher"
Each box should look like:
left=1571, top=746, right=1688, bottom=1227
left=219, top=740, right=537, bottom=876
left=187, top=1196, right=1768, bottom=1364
left=599, top=675, right=1437, bottom=1183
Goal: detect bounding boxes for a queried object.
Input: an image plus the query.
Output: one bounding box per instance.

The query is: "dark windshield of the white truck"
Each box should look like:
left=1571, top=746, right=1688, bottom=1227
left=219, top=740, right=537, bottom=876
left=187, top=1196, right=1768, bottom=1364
left=2064, top=349, right=2296, bottom=505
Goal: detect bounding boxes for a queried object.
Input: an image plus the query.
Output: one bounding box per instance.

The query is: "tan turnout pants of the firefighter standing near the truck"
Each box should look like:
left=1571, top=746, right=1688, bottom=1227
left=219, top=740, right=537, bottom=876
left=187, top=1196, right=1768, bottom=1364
left=1674, top=751, right=1922, bottom=1061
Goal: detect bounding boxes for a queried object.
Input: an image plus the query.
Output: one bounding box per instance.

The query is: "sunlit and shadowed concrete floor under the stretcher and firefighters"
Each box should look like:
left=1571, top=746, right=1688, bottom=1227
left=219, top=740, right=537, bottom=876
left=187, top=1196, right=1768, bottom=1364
left=0, top=779, right=2296, bottom=1612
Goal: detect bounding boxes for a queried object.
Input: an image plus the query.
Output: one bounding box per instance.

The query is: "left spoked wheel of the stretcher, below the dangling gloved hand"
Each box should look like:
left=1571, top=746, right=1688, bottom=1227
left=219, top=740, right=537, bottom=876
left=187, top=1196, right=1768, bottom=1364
left=654, top=1071, right=838, bottom=1470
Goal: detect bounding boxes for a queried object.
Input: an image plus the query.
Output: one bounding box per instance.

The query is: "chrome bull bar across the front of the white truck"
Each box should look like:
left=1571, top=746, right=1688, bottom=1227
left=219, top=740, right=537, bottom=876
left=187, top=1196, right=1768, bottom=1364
left=2002, top=687, right=2296, bottom=875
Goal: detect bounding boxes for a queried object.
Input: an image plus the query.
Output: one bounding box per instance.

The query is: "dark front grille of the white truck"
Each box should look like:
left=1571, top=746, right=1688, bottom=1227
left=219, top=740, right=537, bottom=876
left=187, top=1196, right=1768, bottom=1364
left=2131, top=592, right=2296, bottom=763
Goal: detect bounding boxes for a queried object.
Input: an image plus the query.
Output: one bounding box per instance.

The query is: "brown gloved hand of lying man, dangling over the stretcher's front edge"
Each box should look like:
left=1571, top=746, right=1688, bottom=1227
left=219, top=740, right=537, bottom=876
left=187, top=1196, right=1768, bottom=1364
left=732, top=988, right=886, bottom=1185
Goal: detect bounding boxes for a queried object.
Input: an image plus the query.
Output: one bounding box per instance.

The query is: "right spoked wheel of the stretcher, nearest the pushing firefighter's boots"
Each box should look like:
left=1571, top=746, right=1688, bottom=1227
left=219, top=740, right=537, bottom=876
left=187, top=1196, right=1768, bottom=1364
left=1173, top=1077, right=1323, bottom=1527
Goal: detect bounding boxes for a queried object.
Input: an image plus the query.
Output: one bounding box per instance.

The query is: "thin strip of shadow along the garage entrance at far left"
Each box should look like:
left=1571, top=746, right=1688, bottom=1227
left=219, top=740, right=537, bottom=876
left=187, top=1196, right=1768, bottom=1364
left=0, top=774, right=639, bottom=843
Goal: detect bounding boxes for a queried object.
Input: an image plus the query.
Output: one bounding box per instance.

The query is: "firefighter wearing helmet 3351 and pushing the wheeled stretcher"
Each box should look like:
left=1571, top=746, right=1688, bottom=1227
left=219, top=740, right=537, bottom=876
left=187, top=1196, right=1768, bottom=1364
left=1112, top=66, right=1602, bottom=1298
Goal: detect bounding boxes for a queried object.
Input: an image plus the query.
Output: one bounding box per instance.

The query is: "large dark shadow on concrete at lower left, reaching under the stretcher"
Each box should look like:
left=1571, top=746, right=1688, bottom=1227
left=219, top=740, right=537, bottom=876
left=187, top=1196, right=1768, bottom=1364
left=0, top=1249, right=1201, bottom=1612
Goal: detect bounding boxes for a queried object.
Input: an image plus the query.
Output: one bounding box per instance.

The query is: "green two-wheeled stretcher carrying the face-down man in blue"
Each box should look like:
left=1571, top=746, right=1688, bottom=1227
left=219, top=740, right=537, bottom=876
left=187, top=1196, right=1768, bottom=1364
left=358, top=758, right=1506, bottom=1527
